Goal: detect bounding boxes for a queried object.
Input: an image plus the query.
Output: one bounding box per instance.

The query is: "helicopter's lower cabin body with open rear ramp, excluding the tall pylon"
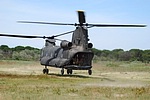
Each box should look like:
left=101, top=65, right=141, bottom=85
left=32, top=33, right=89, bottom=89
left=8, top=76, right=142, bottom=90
left=40, top=46, right=94, bottom=70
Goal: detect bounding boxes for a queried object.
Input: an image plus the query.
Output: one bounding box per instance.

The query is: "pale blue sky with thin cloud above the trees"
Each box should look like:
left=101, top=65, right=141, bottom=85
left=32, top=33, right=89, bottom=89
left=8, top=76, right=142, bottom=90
left=0, top=0, right=150, bottom=50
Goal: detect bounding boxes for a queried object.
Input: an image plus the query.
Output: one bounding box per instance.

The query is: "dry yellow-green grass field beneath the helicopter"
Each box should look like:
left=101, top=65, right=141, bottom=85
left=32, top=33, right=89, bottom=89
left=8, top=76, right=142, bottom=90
left=0, top=60, right=150, bottom=100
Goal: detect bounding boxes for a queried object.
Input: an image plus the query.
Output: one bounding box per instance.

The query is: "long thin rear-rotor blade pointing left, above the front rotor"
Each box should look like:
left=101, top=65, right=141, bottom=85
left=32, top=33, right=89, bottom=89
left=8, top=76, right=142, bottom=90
left=17, top=21, right=75, bottom=26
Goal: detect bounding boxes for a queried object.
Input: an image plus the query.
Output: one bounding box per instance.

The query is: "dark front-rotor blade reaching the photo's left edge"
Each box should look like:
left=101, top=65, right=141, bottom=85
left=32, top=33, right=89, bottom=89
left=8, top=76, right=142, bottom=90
left=0, top=33, right=47, bottom=39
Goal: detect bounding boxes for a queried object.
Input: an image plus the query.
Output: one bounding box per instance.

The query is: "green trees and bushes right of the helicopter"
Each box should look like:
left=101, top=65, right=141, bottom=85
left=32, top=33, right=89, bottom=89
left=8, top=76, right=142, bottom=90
left=92, top=48, right=150, bottom=63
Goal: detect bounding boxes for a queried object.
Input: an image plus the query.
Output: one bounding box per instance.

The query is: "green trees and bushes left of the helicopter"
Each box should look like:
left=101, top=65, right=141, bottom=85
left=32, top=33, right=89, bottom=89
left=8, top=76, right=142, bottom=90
left=0, top=45, right=40, bottom=60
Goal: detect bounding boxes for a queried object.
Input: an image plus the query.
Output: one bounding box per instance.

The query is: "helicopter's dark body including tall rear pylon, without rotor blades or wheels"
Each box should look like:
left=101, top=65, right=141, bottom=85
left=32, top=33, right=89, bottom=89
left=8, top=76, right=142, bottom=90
left=40, top=27, right=94, bottom=70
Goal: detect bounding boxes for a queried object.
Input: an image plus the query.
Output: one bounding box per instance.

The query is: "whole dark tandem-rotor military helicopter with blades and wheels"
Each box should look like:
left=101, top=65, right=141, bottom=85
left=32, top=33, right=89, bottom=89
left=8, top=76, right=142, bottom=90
left=0, top=11, right=146, bottom=75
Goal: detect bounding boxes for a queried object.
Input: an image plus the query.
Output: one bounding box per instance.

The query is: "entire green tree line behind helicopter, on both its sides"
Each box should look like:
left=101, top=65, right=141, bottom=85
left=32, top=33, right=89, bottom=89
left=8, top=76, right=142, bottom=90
left=0, top=45, right=150, bottom=63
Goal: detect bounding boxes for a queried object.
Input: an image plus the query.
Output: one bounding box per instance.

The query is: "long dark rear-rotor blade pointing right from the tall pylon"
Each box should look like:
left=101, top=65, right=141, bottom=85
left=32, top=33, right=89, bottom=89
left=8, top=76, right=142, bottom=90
left=88, top=24, right=146, bottom=27
